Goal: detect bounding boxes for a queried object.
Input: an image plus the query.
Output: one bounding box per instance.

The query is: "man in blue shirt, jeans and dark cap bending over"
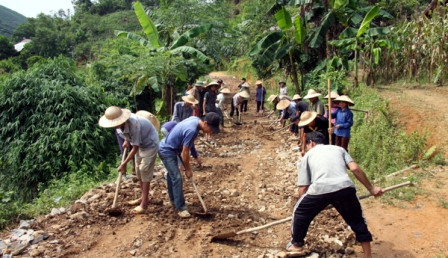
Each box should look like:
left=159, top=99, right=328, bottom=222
left=159, top=112, right=220, bottom=218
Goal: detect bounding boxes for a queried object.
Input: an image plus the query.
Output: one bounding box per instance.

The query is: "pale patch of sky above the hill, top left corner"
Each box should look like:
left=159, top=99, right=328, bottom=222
left=0, top=0, right=74, bottom=18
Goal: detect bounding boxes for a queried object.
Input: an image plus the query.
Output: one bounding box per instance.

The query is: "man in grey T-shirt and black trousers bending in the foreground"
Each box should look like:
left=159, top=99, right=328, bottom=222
left=286, top=132, right=384, bottom=258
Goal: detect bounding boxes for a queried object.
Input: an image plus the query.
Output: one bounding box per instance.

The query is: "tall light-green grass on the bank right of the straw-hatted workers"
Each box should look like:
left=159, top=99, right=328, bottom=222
left=349, top=86, right=426, bottom=179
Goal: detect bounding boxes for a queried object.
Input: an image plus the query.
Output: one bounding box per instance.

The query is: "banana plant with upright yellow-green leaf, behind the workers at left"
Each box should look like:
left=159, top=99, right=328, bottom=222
left=115, top=1, right=212, bottom=115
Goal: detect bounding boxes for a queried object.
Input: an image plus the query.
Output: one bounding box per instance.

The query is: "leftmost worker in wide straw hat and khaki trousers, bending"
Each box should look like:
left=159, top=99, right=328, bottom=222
left=98, top=106, right=159, bottom=214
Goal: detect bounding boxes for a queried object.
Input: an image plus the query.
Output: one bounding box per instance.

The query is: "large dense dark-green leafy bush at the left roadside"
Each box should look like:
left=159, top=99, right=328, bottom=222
left=0, top=58, right=116, bottom=199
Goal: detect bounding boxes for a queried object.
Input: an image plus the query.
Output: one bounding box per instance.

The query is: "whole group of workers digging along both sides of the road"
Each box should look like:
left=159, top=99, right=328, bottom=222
left=99, top=78, right=383, bottom=257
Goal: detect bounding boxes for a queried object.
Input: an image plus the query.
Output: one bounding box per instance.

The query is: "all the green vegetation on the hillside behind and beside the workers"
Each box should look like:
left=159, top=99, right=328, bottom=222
left=0, top=0, right=448, bottom=226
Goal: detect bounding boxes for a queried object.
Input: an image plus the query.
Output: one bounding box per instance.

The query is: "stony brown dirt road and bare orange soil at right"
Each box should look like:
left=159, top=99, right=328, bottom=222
left=1, top=73, right=448, bottom=257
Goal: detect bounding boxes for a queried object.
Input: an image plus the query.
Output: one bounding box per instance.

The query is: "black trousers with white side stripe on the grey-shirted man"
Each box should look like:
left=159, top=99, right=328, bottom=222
left=291, top=187, right=372, bottom=246
